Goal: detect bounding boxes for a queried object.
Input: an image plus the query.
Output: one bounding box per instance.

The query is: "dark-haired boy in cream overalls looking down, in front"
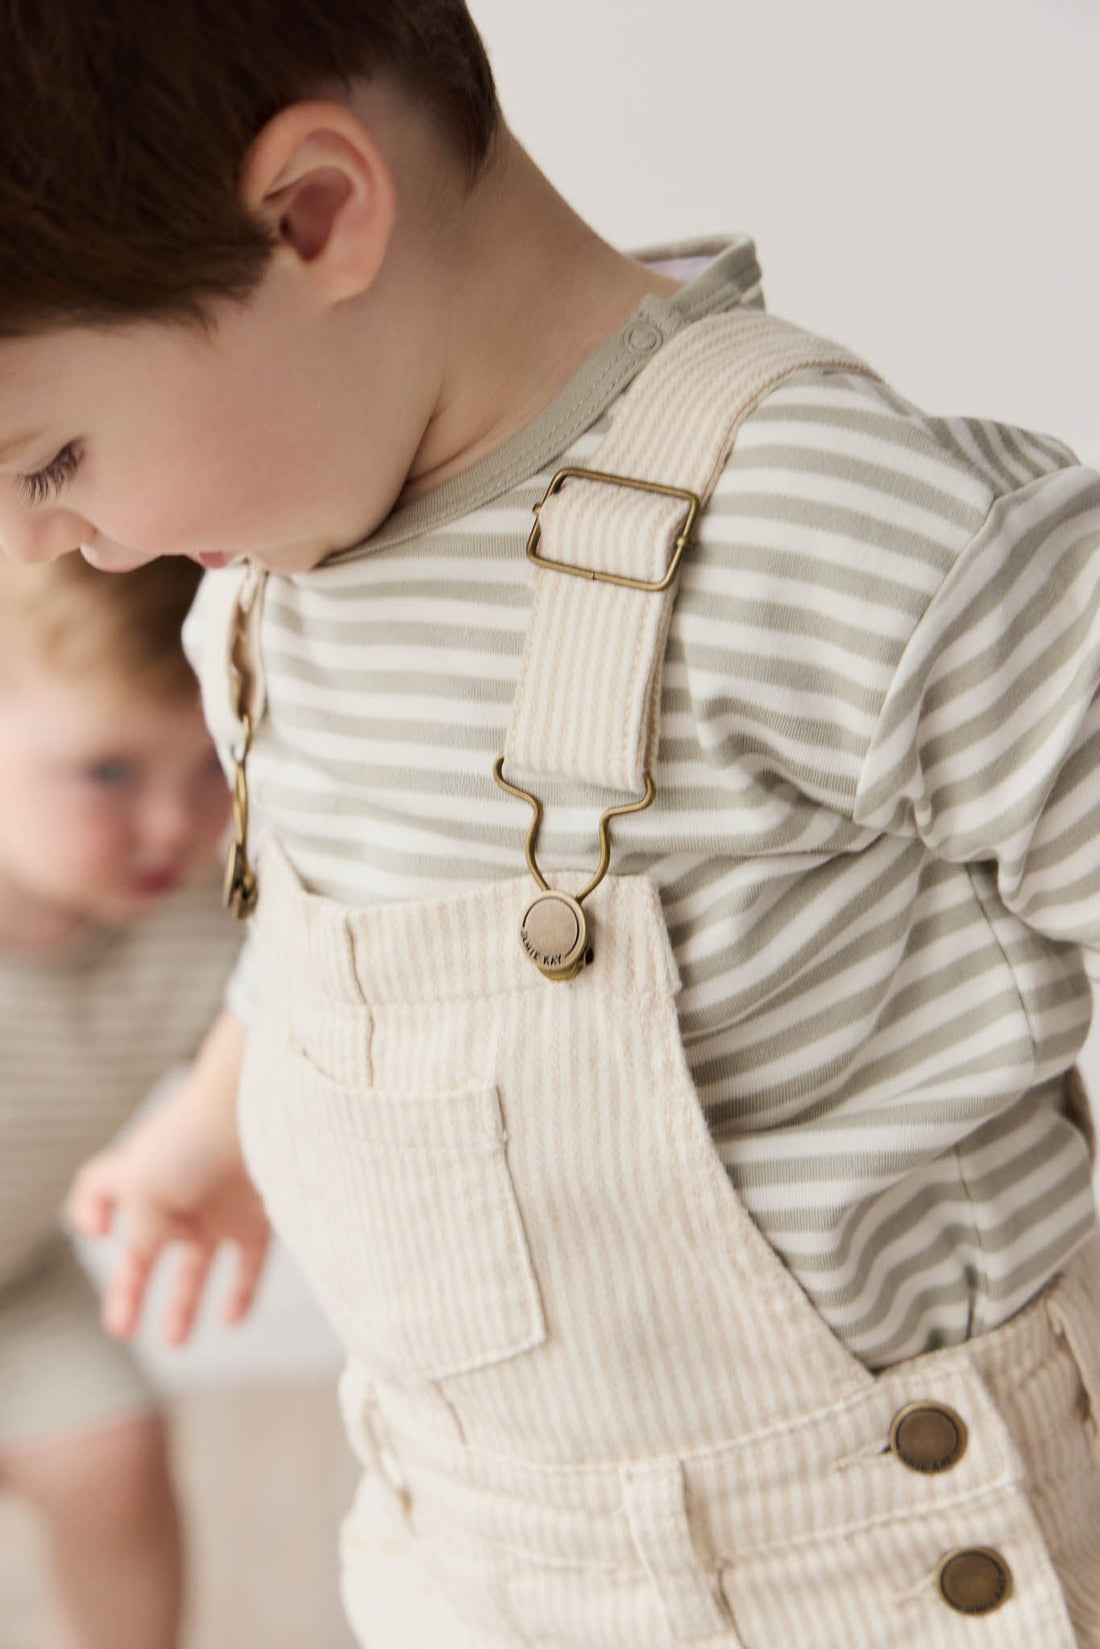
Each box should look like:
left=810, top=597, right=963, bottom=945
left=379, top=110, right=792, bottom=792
left=0, top=0, right=1100, bottom=1649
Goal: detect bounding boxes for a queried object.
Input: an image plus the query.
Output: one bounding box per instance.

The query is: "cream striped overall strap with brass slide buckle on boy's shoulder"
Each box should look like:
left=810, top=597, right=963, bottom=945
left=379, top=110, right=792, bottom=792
left=501, top=310, right=877, bottom=795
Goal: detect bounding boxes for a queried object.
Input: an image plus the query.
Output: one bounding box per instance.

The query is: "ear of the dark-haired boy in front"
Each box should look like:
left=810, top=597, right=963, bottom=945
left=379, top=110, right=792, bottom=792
left=239, top=102, right=397, bottom=302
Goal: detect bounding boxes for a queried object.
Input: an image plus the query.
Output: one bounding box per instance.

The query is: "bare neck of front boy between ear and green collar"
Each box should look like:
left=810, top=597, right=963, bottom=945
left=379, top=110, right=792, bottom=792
left=401, top=130, right=679, bottom=503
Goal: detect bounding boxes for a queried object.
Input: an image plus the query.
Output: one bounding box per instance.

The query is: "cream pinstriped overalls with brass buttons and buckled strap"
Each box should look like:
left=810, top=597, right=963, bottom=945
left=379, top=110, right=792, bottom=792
left=225, top=313, right=1100, bottom=1649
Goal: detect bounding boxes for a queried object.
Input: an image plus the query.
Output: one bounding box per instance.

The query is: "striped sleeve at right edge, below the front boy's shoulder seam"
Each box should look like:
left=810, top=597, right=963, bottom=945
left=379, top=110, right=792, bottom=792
left=854, top=465, right=1100, bottom=951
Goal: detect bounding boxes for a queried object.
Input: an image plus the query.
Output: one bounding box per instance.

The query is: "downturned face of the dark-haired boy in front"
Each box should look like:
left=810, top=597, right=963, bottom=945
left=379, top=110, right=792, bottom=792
left=0, top=253, right=417, bottom=572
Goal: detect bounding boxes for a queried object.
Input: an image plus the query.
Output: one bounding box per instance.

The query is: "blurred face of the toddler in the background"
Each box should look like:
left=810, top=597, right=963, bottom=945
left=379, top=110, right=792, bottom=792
left=0, top=665, right=229, bottom=922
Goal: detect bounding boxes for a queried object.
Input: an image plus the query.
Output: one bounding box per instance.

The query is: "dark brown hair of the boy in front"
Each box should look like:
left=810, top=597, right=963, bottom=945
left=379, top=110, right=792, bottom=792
left=0, top=0, right=500, bottom=336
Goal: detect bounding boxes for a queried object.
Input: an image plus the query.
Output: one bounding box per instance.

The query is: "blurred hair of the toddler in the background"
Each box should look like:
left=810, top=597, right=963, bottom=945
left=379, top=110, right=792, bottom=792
left=0, top=551, right=201, bottom=701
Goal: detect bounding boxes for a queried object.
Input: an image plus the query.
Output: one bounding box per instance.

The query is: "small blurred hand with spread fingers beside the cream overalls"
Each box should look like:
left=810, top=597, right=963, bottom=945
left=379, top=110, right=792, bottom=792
left=68, top=1028, right=270, bottom=1346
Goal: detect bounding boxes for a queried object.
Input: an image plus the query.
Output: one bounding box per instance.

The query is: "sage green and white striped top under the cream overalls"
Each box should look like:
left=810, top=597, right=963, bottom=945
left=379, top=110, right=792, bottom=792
left=188, top=241, right=1100, bottom=1367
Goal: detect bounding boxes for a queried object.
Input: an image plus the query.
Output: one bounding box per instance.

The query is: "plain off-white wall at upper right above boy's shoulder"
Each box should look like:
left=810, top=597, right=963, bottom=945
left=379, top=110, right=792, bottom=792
left=472, top=0, right=1100, bottom=445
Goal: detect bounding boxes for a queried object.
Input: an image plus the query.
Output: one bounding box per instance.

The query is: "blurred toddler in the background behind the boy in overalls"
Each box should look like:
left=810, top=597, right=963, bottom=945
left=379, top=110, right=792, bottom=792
left=0, top=557, right=258, bottom=1649
